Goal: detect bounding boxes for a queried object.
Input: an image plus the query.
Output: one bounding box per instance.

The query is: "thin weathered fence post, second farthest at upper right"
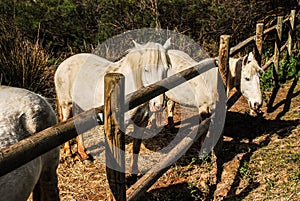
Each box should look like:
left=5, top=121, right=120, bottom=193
left=273, top=16, right=283, bottom=85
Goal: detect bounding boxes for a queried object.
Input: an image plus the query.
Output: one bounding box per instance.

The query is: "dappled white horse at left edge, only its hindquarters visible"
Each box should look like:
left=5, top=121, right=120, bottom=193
left=0, top=86, right=59, bottom=201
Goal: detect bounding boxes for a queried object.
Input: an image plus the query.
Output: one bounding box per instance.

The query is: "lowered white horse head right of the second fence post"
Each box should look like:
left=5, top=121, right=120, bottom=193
left=240, top=52, right=263, bottom=112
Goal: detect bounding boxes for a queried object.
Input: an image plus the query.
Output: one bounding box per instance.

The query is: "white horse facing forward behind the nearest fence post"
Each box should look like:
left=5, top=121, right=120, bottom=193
left=55, top=39, right=170, bottom=171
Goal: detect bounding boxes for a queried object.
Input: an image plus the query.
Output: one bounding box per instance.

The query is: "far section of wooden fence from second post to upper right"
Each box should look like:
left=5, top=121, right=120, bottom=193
left=225, top=10, right=296, bottom=109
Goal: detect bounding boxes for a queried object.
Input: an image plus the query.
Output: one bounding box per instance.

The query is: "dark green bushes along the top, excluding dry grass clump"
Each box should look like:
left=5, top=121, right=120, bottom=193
left=0, top=0, right=296, bottom=56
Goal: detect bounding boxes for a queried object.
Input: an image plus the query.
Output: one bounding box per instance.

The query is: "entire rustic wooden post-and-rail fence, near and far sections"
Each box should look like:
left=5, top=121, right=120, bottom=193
left=0, top=10, right=295, bottom=200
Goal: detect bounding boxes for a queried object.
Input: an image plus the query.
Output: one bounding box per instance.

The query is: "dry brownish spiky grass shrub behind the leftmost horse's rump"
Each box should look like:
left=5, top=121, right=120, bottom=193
left=0, top=21, right=54, bottom=97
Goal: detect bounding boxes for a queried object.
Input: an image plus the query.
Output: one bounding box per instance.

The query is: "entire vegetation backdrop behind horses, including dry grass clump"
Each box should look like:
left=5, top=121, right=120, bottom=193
left=0, top=0, right=299, bottom=97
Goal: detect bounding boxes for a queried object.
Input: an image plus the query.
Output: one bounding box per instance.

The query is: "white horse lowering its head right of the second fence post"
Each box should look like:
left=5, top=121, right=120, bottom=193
left=150, top=50, right=263, bottom=128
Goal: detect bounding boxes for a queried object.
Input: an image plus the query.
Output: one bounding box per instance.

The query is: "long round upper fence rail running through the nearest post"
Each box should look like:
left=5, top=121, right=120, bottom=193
left=0, top=59, right=216, bottom=176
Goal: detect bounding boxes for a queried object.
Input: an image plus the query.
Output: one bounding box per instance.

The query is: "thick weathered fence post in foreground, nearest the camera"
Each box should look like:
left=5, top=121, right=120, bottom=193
left=104, top=73, right=126, bottom=201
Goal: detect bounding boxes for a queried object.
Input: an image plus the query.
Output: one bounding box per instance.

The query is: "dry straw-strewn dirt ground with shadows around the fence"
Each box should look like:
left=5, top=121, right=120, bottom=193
left=58, top=78, right=300, bottom=201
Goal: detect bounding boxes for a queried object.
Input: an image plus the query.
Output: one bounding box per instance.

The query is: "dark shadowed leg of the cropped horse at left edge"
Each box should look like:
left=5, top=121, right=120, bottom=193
left=33, top=148, right=60, bottom=201
